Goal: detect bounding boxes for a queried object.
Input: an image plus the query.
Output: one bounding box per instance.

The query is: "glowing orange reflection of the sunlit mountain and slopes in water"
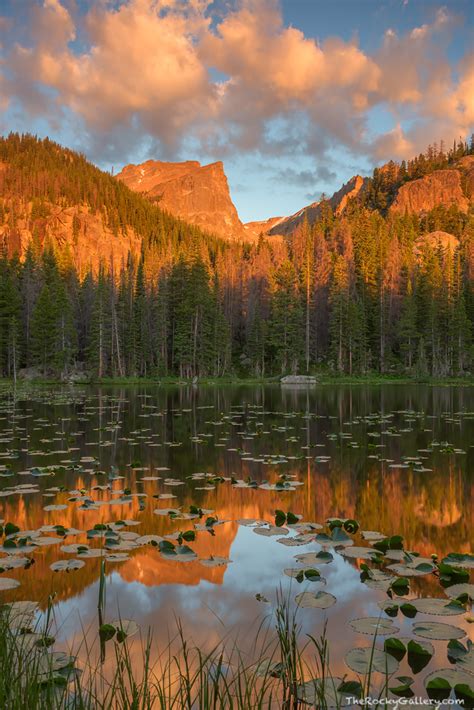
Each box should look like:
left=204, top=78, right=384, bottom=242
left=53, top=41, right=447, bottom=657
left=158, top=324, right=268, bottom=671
left=4, top=457, right=473, bottom=603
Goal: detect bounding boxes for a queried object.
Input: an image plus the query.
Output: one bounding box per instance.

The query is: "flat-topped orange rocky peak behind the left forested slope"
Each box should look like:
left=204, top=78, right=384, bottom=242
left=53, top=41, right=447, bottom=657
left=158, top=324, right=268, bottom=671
left=117, top=160, right=248, bottom=239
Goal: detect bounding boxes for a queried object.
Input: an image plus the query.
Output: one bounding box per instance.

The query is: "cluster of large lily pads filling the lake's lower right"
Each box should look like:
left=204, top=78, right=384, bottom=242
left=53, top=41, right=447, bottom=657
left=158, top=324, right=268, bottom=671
left=239, top=510, right=474, bottom=707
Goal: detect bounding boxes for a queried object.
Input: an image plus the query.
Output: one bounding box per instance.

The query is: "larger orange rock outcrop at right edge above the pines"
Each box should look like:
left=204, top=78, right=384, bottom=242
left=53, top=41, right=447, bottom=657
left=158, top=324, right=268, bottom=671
left=390, top=169, right=469, bottom=214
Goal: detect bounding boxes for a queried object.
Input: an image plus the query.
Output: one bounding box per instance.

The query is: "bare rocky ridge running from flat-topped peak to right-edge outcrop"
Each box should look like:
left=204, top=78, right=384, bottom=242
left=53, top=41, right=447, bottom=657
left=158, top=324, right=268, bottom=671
left=117, top=155, right=474, bottom=241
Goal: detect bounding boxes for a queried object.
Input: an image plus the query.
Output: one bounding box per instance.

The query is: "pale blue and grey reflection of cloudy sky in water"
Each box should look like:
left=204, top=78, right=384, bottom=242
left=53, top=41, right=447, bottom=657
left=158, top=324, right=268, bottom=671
left=49, top=526, right=386, bottom=660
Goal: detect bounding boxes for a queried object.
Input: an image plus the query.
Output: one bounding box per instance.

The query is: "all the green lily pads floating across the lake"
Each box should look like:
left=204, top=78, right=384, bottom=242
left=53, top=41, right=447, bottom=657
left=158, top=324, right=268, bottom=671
left=0, top=393, right=474, bottom=707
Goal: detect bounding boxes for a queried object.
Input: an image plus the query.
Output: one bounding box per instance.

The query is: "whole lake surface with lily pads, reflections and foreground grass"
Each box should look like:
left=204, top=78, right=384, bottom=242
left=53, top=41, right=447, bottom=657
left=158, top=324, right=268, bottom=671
left=0, top=389, right=474, bottom=709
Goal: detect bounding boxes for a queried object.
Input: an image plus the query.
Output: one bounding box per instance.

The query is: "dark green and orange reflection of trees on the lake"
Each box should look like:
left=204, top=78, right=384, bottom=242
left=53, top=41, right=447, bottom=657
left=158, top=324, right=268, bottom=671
left=1, top=386, right=474, bottom=616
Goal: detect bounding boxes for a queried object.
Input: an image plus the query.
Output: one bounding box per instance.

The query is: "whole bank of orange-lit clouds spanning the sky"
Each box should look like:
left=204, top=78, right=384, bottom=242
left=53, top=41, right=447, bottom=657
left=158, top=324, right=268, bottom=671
left=0, top=0, right=474, bottom=165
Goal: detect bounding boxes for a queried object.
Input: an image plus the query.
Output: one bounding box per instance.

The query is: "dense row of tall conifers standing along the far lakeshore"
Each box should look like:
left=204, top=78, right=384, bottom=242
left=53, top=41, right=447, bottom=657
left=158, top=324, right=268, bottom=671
left=0, top=210, right=474, bottom=377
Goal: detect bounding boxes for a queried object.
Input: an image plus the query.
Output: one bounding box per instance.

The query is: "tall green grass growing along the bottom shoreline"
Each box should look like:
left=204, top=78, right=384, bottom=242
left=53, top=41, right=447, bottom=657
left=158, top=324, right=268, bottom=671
left=0, top=585, right=474, bottom=710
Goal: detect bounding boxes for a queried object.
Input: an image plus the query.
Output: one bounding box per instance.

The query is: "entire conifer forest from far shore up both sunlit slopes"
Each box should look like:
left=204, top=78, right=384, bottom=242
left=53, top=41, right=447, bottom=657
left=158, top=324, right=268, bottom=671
left=0, top=135, right=474, bottom=377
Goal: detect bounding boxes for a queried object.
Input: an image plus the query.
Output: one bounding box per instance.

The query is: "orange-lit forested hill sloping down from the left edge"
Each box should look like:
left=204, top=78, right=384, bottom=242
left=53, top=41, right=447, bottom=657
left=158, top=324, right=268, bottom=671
left=0, top=134, right=221, bottom=277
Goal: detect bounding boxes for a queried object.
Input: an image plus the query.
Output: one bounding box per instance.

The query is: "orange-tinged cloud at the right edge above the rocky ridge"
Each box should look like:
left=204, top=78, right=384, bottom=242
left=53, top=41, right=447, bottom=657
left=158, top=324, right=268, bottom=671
left=373, top=8, right=474, bottom=160
